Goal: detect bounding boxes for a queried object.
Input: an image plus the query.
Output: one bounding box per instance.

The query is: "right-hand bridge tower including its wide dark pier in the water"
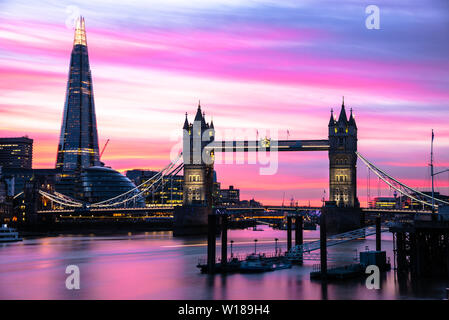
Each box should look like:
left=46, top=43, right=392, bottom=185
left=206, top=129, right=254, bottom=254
left=325, top=98, right=358, bottom=233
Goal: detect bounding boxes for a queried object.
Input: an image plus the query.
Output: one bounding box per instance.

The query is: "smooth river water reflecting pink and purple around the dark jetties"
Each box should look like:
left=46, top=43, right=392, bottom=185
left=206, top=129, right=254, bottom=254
left=0, top=226, right=449, bottom=299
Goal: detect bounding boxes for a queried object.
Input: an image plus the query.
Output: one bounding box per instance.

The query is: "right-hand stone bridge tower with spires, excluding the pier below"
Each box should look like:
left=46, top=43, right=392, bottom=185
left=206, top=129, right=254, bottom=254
left=329, top=98, right=360, bottom=208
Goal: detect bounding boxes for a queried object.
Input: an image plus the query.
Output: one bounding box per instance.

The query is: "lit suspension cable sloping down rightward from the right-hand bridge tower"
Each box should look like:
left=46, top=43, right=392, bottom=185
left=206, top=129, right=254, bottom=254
left=355, top=151, right=449, bottom=206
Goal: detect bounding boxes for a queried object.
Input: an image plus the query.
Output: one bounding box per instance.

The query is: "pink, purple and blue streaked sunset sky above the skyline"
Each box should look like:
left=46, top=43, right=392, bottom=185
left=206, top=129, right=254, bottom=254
left=0, top=0, right=449, bottom=205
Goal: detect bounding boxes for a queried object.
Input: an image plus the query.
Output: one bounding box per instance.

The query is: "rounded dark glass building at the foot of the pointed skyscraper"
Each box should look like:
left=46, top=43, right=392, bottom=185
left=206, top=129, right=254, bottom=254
left=78, top=166, right=145, bottom=207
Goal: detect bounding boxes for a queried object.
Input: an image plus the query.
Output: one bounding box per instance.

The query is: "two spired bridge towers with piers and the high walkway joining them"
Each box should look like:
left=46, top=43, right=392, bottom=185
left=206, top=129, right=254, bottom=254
left=175, top=100, right=362, bottom=234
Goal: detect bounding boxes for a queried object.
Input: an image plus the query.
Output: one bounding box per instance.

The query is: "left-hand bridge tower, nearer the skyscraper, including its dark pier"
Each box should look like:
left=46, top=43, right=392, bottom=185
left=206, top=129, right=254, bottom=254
left=174, top=103, right=215, bottom=235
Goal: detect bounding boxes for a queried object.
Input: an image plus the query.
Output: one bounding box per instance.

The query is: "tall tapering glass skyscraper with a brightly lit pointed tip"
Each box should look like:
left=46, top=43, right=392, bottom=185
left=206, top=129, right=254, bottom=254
left=56, top=17, right=100, bottom=171
